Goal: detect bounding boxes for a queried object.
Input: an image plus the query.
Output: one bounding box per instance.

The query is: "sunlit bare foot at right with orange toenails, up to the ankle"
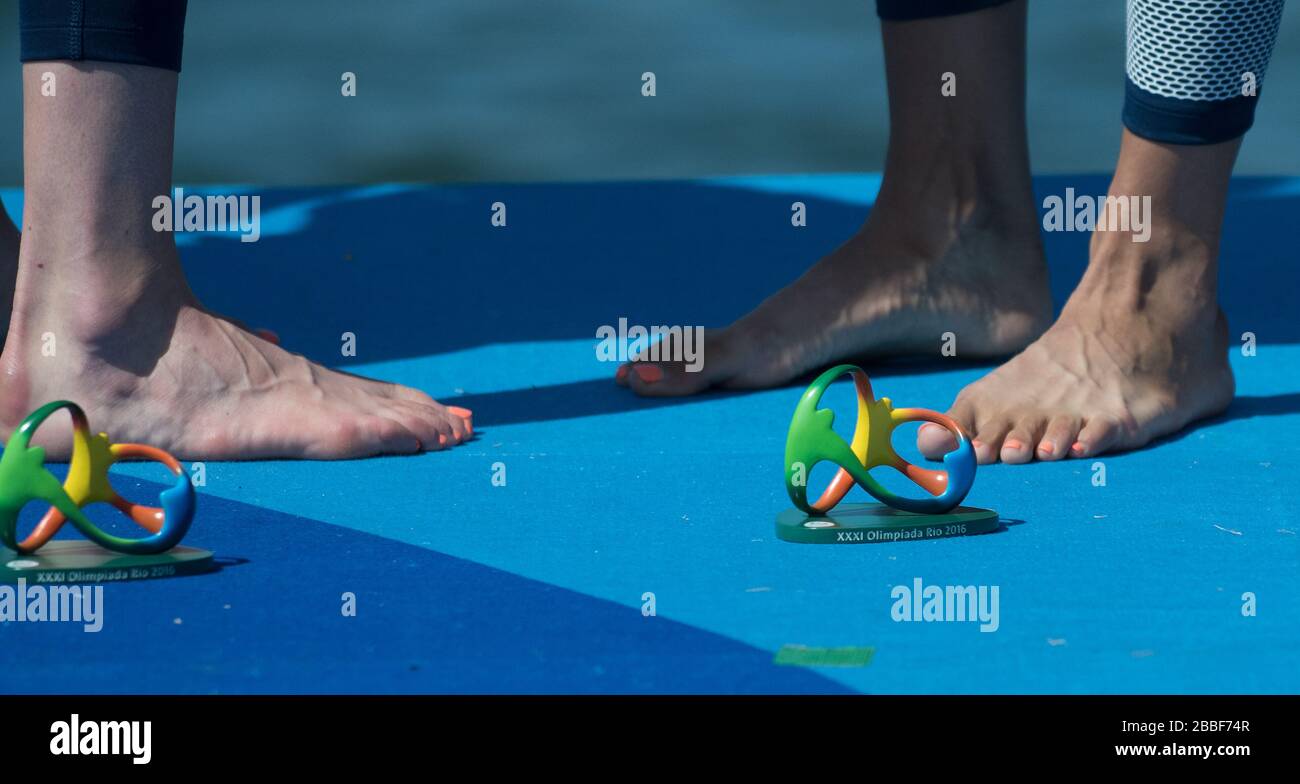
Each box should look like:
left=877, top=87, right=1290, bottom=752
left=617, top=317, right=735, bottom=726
left=918, top=233, right=1234, bottom=463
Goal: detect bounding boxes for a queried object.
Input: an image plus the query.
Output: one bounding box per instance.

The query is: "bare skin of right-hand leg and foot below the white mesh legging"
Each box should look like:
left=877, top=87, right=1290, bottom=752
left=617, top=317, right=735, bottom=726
left=920, top=131, right=1240, bottom=463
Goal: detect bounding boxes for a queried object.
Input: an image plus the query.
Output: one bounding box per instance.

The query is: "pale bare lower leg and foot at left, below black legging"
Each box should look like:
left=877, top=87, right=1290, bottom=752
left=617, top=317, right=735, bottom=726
left=0, top=61, right=469, bottom=459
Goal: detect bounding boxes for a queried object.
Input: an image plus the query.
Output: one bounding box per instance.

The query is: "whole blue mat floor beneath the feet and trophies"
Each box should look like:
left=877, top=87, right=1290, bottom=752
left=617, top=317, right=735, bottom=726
left=0, top=176, right=1300, bottom=693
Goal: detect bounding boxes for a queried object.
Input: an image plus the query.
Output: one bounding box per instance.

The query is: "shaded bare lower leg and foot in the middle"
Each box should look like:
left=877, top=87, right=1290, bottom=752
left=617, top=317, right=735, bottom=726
left=619, top=0, right=1050, bottom=395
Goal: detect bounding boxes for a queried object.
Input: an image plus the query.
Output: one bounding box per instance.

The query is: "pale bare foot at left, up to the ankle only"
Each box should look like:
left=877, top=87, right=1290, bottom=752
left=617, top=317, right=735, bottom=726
left=0, top=243, right=473, bottom=459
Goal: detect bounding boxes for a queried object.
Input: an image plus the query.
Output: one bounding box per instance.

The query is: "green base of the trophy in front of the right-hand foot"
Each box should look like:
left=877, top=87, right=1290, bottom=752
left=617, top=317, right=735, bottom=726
left=776, top=503, right=1000, bottom=545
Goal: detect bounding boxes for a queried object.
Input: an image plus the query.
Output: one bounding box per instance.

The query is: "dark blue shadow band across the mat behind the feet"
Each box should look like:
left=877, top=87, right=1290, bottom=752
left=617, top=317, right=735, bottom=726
left=172, top=176, right=1300, bottom=364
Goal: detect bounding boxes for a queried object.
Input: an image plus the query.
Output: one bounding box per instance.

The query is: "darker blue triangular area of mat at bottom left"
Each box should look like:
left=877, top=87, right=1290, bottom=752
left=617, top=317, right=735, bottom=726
left=0, top=477, right=849, bottom=693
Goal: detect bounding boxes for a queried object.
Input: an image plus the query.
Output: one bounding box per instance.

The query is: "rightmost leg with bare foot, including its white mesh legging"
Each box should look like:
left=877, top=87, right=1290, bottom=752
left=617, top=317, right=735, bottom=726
left=919, top=0, right=1283, bottom=463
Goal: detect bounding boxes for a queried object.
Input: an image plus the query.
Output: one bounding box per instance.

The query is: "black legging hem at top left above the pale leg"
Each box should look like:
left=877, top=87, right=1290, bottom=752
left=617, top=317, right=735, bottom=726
left=18, top=0, right=186, bottom=70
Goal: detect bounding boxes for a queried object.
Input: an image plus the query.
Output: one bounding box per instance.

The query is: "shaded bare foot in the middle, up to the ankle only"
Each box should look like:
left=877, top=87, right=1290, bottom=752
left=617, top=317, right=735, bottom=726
left=616, top=197, right=1052, bottom=395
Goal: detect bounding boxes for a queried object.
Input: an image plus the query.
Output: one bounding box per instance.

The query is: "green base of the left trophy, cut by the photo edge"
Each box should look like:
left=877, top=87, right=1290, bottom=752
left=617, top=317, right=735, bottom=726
left=0, top=540, right=216, bottom=585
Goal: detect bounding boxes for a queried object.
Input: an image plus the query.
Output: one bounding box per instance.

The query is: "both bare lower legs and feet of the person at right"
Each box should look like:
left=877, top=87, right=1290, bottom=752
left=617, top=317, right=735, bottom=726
left=616, top=0, right=1240, bottom=463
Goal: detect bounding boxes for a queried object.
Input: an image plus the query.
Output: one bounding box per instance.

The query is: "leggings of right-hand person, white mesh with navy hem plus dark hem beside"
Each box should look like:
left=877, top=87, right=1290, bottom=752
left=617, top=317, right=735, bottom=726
left=876, top=0, right=1284, bottom=144
